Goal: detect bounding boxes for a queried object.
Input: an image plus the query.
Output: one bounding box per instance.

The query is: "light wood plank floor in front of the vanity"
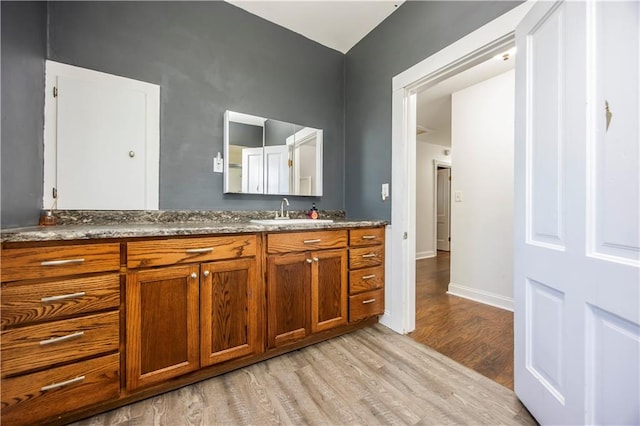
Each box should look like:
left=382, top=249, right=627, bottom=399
left=72, top=324, right=535, bottom=425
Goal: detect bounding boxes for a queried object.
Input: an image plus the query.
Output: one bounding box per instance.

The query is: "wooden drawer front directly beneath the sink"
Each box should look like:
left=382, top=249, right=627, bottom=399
left=267, top=230, right=347, bottom=253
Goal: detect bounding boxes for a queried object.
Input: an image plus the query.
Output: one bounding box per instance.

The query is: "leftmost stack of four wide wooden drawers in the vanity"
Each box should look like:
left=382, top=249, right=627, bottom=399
left=0, top=243, right=120, bottom=425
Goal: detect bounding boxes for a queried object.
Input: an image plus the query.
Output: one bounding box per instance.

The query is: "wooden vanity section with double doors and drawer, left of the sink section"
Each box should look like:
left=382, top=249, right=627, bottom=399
left=126, top=234, right=261, bottom=391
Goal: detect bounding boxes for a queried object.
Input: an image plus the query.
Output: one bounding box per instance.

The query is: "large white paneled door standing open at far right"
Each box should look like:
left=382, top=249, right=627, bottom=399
left=514, top=1, right=640, bottom=425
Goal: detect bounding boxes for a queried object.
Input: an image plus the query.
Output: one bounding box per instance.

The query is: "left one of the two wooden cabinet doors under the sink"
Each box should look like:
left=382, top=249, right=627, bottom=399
left=267, top=253, right=312, bottom=347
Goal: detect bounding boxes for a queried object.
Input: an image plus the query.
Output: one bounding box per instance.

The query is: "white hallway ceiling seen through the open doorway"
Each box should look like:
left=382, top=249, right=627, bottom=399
left=416, top=49, right=515, bottom=146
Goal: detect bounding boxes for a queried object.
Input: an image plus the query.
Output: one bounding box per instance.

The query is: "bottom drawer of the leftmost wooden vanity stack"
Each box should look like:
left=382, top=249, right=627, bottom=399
left=2, top=354, right=120, bottom=425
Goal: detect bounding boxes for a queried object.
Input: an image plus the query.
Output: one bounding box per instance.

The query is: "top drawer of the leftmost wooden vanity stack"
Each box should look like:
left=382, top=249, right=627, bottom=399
left=2, top=243, right=120, bottom=282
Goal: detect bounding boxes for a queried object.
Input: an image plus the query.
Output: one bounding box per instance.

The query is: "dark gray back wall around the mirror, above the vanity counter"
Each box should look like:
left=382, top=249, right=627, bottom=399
left=48, top=1, right=344, bottom=215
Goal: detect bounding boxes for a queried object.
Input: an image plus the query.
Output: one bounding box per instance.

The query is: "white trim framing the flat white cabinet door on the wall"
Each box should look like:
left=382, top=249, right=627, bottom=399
left=42, top=60, right=160, bottom=210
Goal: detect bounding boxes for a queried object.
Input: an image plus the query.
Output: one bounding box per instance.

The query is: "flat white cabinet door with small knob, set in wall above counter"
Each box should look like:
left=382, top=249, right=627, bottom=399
left=57, top=76, right=148, bottom=210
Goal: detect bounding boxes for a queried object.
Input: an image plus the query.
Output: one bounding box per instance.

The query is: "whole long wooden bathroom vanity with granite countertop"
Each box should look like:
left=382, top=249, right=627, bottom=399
left=1, top=215, right=385, bottom=424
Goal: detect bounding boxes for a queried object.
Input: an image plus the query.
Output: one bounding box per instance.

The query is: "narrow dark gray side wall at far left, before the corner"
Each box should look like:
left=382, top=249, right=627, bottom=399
left=0, top=1, right=47, bottom=228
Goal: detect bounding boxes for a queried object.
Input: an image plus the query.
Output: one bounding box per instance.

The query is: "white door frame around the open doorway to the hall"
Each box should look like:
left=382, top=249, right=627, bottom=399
left=380, top=0, right=534, bottom=334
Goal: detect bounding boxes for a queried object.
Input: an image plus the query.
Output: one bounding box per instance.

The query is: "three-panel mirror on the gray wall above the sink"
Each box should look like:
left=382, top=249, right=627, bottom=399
left=224, top=111, right=322, bottom=196
